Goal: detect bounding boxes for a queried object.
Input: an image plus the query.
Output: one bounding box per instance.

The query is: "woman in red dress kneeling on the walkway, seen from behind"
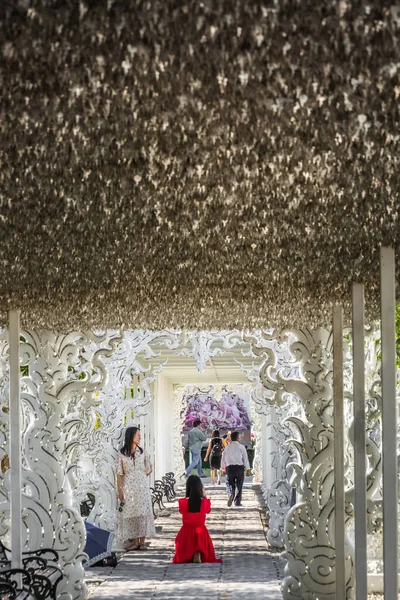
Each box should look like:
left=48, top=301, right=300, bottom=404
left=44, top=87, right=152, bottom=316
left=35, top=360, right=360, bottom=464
left=172, top=475, right=222, bottom=563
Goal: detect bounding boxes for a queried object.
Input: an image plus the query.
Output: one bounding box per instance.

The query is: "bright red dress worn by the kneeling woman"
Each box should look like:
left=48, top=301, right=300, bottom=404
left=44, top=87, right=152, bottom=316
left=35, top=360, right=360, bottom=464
left=172, top=498, right=222, bottom=563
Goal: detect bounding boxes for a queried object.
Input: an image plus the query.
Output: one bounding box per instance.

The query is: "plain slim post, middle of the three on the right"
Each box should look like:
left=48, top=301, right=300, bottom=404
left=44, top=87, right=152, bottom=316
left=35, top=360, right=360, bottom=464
left=353, top=283, right=368, bottom=600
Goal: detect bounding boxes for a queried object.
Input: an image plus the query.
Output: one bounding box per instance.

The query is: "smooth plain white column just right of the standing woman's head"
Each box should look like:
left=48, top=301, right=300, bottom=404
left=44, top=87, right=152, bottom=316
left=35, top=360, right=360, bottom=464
left=154, top=375, right=173, bottom=479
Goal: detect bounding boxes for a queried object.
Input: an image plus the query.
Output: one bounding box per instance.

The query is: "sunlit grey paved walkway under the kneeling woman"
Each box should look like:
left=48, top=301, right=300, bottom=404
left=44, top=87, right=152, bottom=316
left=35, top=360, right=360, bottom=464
left=88, top=484, right=283, bottom=600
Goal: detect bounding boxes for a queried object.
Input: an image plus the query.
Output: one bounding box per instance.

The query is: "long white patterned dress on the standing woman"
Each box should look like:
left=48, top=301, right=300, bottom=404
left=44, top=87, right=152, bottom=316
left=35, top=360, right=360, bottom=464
left=117, top=450, right=156, bottom=542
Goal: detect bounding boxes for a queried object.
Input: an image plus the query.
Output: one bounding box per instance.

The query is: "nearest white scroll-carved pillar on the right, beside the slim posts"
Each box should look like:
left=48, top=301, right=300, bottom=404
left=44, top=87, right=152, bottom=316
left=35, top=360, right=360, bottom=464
left=282, top=329, right=353, bottom=600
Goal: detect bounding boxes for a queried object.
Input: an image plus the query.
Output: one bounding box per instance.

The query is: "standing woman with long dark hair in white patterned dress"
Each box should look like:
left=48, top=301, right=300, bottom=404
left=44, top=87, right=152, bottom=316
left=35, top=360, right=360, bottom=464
left=117, top=427, right=156, bottom=550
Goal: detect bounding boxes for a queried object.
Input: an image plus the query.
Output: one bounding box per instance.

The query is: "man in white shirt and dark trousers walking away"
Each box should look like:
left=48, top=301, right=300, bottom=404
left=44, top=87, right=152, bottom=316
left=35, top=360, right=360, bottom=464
left=221, top=431, right=251, bottom=506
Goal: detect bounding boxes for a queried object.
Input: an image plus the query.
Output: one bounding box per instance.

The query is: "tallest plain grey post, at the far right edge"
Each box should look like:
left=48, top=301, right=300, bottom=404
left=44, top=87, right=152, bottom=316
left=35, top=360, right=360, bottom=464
left=381, top=248, right=398, bottom=600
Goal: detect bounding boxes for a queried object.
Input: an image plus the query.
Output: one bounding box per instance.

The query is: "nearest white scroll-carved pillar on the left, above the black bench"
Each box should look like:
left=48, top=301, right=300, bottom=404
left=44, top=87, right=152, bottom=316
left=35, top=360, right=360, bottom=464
left=21, top=331, right=104, bottom=600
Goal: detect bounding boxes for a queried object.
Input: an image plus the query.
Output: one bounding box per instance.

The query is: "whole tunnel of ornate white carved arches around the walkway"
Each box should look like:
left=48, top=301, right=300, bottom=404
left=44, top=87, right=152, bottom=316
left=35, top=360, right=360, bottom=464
left=0, top=327, right=394, bottom=600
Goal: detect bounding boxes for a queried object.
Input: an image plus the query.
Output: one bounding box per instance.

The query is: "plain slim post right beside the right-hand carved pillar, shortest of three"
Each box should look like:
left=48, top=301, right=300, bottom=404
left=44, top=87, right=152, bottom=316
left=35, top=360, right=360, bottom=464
left=333, top=305, right=346, bottom=600
